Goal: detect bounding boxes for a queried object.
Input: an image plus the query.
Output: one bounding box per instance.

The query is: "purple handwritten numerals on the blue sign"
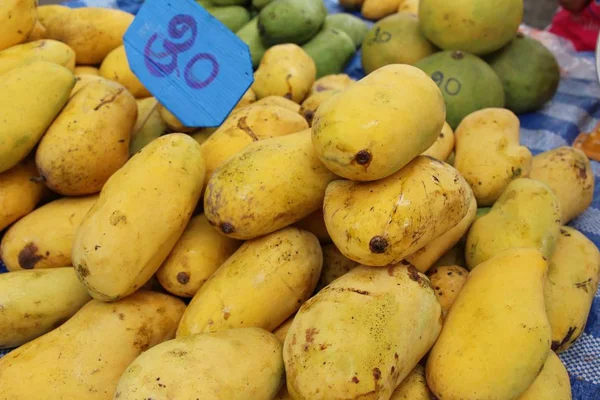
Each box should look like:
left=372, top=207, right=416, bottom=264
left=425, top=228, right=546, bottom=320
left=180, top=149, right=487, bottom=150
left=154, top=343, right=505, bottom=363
left=144, top=14, right=219, bottom=89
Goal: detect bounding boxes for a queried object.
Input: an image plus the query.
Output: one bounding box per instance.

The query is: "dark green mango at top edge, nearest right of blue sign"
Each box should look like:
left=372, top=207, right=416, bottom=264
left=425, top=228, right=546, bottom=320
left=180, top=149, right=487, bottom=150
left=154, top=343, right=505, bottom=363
left=258, top=0, right=327, bottom=46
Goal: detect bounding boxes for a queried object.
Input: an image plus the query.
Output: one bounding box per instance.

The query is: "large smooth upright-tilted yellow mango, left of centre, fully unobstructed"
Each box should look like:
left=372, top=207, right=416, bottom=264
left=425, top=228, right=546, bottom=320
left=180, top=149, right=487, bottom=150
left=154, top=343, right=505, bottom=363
left=72, top=134, right=204, bottom=301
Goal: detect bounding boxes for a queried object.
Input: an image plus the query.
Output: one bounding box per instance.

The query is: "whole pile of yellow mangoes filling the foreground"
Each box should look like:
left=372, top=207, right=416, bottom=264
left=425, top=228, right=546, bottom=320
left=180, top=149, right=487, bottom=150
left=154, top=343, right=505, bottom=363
left=0, top=0, right=600, bottom=400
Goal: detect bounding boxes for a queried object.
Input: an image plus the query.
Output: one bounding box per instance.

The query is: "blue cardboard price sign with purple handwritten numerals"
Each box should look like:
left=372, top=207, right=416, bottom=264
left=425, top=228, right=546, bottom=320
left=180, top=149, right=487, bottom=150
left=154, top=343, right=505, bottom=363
left=123, top=0, right=254, bottom=127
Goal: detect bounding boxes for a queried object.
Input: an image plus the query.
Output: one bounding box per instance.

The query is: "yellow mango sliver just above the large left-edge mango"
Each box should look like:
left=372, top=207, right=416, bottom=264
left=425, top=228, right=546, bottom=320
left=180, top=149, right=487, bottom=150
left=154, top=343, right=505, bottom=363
left=0, top=40, right=75, bottom=74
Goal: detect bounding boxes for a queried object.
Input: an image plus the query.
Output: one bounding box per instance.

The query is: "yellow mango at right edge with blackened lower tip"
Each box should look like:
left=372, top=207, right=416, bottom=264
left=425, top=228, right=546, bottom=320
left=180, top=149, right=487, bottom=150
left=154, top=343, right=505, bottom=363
left=544, top=226, right=600, bottom=353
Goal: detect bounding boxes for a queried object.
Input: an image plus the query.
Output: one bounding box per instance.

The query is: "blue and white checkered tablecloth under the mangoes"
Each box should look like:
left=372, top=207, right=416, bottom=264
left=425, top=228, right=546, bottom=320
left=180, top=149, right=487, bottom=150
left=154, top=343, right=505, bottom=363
left=0, top=0, right=600, bottom=400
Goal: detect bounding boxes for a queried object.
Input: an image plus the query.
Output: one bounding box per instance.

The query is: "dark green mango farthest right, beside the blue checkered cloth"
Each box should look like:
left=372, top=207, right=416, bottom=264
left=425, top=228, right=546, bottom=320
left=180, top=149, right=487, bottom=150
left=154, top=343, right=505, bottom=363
left=486, top=33, right=560, bottom=114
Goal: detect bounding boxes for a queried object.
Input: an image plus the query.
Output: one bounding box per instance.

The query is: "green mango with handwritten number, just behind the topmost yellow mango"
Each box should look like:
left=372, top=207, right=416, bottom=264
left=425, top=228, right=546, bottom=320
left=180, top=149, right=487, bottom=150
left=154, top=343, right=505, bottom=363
left=415, top=51, right=505, bottom=129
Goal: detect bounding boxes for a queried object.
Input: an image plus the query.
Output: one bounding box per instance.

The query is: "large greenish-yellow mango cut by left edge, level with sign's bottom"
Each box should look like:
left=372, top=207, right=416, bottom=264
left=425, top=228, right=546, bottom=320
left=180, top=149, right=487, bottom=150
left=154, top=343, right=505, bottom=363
left=0, top=61, right=75, bottom=173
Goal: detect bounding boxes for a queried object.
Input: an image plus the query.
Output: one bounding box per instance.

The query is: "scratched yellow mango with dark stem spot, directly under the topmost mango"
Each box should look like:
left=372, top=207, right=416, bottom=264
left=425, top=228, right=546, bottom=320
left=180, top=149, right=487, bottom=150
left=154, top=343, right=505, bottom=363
left=323, top=156, right=471, bottom=266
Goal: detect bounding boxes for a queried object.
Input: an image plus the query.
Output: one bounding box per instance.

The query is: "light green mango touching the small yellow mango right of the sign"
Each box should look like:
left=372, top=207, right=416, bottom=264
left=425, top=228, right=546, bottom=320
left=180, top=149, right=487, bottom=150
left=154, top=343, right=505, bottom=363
left=302, top=28, right=356, bottom=79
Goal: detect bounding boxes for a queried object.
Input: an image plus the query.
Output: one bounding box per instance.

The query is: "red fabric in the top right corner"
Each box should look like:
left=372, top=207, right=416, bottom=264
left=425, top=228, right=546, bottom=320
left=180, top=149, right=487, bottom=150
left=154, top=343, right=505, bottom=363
left=550, top=0, right=600, bottom=51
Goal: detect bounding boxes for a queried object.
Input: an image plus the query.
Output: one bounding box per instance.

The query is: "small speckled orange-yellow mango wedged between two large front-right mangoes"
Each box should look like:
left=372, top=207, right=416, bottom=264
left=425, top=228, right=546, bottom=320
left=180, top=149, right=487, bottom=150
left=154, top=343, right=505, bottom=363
left=427, top=265, right=469, bottom=318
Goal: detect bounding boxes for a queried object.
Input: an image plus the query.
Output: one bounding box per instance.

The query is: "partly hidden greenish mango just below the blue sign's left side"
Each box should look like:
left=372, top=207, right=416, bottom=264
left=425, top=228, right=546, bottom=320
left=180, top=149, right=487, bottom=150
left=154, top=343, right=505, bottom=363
left=129, top=97, right=167, bottom=155
